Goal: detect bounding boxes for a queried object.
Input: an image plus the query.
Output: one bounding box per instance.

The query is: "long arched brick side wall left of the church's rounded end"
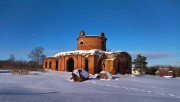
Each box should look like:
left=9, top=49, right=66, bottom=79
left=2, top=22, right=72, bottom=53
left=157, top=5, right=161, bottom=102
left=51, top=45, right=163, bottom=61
left=43, top=55, right=98, bottom=74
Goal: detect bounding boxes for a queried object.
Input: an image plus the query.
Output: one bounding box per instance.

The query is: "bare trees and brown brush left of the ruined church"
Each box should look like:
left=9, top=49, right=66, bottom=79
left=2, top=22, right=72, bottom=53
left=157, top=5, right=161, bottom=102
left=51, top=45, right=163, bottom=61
left=0, top=47, right=46, bottom=70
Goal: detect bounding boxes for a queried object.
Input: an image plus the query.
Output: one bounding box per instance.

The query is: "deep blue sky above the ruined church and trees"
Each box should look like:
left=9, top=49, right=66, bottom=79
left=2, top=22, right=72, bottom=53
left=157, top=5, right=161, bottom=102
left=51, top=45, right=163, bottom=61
left=0, top=0, right=180, bottom=66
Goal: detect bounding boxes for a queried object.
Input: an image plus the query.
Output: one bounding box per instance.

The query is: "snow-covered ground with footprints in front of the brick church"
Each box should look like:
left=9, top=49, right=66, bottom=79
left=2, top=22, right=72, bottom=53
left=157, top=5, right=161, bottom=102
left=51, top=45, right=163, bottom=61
left=0, top=71, right=180, bottom=102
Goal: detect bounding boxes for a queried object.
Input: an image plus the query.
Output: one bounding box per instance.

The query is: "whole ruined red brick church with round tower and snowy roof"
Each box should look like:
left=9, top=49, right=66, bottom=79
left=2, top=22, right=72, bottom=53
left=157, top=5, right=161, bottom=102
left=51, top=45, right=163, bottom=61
left=43, top=31, right=132, bottom=74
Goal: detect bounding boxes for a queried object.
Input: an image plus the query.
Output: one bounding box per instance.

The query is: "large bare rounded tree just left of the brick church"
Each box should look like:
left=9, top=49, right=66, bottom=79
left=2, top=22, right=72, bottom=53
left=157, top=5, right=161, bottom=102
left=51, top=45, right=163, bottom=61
left=28, top=47, right=46, bottom=67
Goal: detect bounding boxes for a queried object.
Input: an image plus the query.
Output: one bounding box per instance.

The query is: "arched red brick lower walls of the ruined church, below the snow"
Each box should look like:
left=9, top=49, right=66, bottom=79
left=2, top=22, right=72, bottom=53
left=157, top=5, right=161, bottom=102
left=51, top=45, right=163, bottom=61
left=43, top=53, right=132, bottom=74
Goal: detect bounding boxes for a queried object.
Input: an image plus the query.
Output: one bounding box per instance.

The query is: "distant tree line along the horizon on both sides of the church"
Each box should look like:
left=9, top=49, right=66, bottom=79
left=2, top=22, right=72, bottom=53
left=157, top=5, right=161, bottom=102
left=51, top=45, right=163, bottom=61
left=0, top=47, right=180, bottom=76
